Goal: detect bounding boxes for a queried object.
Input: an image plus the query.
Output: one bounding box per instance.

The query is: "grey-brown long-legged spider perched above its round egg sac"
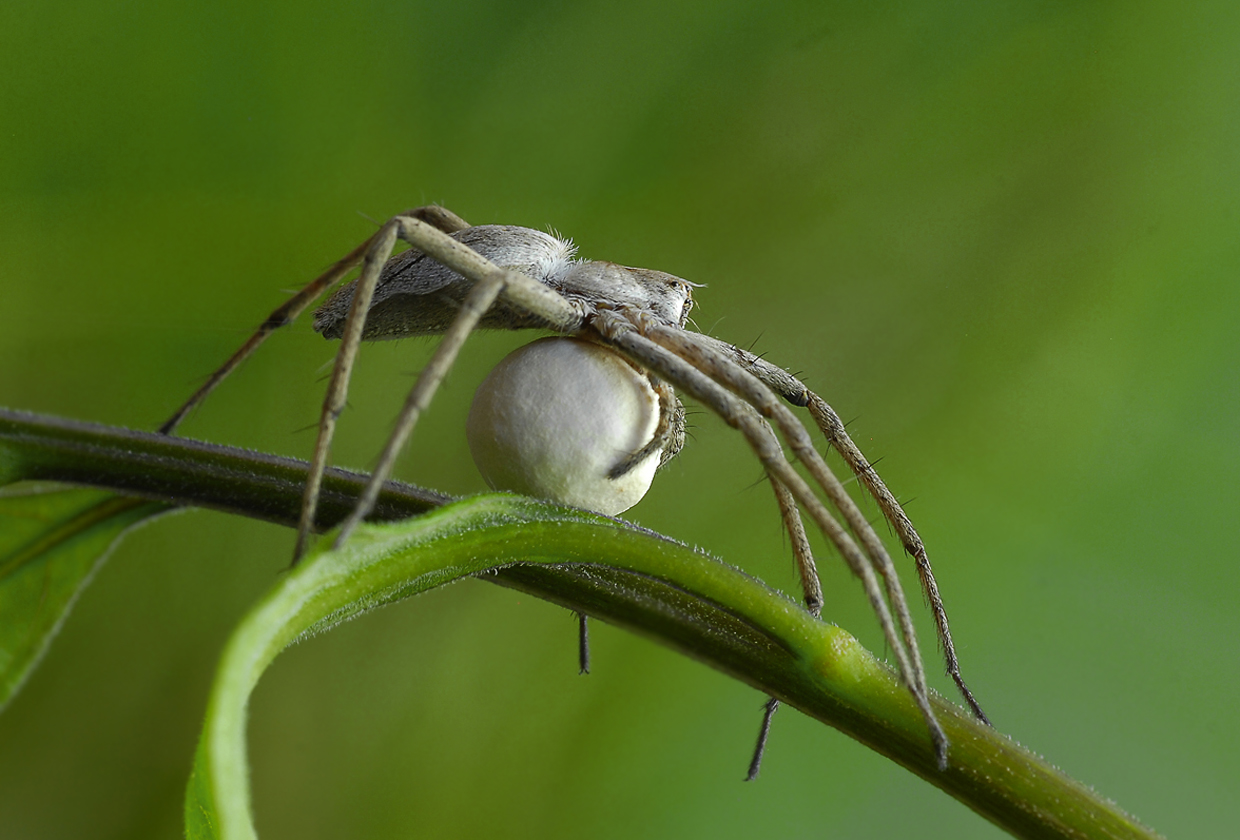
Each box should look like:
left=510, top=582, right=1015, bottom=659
left=160, top=206, right=988, bottom=778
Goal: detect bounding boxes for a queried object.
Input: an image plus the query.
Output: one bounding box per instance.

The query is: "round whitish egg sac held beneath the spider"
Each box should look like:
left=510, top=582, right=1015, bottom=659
left=465, top=337, right=660, bottom=515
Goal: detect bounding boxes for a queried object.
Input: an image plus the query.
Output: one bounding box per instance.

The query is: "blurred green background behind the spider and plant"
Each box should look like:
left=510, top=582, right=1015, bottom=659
left=0, top=0, right=1240, bottom=838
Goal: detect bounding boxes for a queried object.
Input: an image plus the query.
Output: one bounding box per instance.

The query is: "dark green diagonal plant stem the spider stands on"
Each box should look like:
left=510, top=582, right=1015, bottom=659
left=0, top=409, right=1157, bottom=838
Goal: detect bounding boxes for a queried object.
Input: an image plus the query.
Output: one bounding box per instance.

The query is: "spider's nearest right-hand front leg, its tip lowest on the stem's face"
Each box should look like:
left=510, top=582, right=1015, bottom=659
left=591, top=310, right=947, bottom=767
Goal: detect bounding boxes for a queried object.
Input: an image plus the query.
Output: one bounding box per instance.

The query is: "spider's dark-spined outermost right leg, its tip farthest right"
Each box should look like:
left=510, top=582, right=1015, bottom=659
left=693, top=334, right=990, bottom=726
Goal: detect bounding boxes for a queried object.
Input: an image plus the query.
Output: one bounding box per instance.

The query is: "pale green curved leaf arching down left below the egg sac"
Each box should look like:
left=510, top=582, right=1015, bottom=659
left=186, top=495, right=843, bottom=839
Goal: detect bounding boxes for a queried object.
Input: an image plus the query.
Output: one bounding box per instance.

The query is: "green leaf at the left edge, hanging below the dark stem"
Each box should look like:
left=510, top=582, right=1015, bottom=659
left=0, top=489, right=170, bottom=708
